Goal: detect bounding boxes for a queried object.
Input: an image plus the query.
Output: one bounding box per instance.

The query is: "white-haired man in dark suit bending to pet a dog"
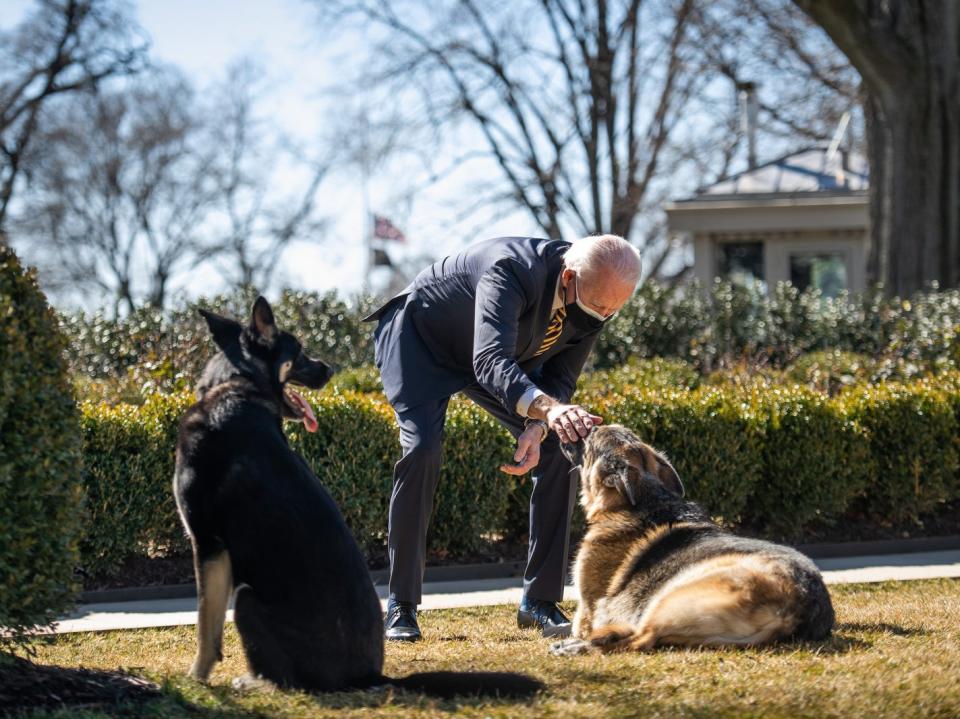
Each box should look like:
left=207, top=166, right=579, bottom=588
left=367, top=235, right=640, bottom=641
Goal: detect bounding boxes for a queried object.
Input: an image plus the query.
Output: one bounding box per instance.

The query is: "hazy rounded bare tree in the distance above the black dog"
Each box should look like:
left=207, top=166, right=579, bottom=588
left=14, top=70, right=216, bottom=313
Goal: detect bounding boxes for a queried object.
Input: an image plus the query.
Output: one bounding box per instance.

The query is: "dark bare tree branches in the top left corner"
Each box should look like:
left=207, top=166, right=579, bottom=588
left=0, top=0, right=147, bottom=243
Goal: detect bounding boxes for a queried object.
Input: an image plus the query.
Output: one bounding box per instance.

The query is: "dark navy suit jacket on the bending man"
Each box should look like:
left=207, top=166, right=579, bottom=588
left=365, top=237, right=600, bottom=412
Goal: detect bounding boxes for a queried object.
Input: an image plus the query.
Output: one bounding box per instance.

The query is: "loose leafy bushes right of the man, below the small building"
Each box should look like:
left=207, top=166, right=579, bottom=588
left=593, top=280, right=960, bottom=380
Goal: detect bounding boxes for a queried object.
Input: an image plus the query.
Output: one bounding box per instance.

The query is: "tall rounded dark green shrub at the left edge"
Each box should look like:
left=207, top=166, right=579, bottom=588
left=0, top=247, right=81, bottom=642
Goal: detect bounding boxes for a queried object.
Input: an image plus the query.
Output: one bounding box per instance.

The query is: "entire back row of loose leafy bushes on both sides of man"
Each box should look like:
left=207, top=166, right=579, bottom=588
left=62, top=281, right=960, bottom=403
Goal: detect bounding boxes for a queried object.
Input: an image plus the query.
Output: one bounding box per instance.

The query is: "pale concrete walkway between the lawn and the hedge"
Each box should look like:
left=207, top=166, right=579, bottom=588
left=48, top=550, right=960, bottom=633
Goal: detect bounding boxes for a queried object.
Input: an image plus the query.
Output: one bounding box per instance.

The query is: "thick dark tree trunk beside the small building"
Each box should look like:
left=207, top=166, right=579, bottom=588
left=794, top=0, right=960, bottom=295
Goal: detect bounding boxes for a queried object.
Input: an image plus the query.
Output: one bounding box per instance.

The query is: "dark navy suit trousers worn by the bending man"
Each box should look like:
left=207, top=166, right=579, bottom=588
left=387, top=385, right=577, bottom=604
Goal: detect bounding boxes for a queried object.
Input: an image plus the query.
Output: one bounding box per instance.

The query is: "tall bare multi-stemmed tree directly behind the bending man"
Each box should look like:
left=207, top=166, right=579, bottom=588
left=323, top=0, right=707, bottom=274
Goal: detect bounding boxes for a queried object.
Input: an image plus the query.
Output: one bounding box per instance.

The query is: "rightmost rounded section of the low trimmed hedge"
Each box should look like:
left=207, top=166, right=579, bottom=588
left=841, top=382, right=958, bottom=521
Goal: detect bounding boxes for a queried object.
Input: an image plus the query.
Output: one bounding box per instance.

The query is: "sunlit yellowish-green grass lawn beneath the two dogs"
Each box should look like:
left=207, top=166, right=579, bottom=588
left=13, top=579, right=960, bottom=719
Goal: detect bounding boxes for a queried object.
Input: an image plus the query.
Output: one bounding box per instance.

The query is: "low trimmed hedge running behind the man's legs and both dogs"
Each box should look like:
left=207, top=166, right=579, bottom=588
left=75, top=375, right=960, bottom=573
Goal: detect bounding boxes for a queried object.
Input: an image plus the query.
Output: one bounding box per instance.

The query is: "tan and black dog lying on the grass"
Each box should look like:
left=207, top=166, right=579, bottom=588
left=551, top=425, right=834, bottom=655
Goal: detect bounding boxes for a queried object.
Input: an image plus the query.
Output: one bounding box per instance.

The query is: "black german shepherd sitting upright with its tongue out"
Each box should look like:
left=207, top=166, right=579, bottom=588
left=173, top=297, right=541, bottom=696
